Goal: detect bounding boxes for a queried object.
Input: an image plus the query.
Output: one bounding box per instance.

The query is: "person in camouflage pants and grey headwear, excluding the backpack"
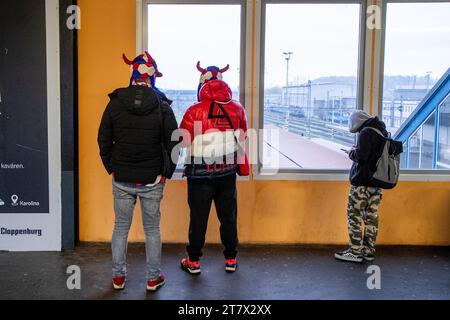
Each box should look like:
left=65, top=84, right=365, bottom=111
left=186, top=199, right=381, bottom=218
left=335, top=111, right=389, bottom=262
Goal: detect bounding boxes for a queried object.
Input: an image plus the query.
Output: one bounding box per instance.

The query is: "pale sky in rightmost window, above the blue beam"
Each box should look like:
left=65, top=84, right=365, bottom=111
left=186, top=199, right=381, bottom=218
left=385, top=3, right=450, bottom=79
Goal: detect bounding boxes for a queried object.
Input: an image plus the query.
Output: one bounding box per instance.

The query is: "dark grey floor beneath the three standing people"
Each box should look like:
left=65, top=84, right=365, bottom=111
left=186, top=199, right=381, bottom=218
left=0, top=244, right=450, bottom=300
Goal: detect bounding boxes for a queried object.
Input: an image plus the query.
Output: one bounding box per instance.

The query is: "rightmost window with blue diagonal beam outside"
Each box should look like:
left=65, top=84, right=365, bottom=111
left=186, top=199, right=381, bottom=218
left=382, top=2, right=450, bottom=169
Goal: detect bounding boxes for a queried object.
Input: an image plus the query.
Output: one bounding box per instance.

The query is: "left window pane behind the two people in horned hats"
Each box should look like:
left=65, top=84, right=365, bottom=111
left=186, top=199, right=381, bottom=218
left=147, top=4, right=241, bottom=168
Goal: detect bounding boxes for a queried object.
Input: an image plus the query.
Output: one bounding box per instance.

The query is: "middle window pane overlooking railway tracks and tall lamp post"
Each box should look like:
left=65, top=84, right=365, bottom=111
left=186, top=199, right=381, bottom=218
left=263, top=4, right=360, bottom=169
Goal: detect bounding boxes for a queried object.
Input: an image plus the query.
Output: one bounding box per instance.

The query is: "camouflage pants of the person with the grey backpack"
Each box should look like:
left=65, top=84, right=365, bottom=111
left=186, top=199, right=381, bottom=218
left=347, top=186, right=383, bottom=254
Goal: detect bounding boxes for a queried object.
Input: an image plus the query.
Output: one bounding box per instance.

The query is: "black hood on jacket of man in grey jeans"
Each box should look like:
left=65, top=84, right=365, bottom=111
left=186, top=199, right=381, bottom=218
left=109, top=86, right=159, bottom=115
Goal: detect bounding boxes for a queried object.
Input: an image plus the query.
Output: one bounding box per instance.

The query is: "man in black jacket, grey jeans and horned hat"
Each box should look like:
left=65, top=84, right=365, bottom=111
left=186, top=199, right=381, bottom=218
left=98, top=54, right=178, bottom=291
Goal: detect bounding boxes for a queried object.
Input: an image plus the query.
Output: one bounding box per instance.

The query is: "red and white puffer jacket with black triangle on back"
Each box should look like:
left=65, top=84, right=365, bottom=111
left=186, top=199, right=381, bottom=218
left=180, top=80, right=248, bottom=177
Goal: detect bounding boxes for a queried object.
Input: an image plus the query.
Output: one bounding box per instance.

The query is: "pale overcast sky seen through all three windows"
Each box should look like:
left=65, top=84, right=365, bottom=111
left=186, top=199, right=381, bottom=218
left=148, top=3, right=450, bottom=90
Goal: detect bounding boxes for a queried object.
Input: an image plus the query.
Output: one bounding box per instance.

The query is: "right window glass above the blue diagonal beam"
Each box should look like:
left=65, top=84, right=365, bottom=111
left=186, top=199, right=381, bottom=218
left=383, top=2, right=450, bottom=134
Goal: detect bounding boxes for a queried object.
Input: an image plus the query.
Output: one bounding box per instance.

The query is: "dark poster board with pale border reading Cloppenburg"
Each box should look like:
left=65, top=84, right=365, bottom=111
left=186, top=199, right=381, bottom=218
left=0, top=0, right=61, bottom=251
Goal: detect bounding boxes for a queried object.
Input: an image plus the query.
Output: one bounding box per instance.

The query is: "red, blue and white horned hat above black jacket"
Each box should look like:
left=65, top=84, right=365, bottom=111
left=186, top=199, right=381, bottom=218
left=122, top=51, right=163, bottom=89
